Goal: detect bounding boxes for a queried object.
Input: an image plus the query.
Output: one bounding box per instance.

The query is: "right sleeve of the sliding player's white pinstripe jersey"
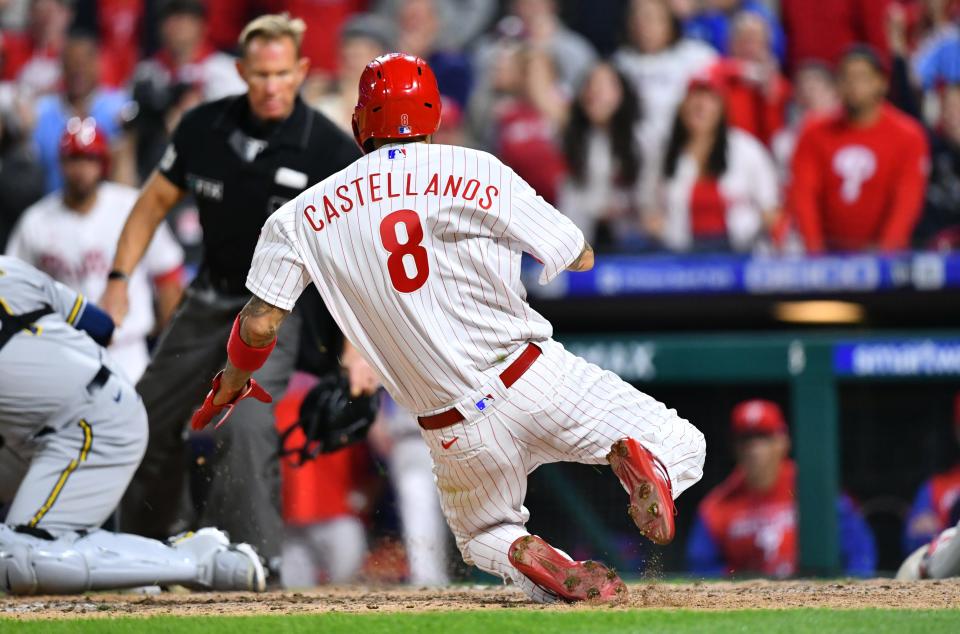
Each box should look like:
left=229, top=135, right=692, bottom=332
left=500, top=168, right=586, bottom=285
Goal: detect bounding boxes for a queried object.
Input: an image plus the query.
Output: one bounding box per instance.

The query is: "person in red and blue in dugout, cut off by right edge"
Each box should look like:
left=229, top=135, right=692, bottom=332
left=903, top=392, right=960, bottom=553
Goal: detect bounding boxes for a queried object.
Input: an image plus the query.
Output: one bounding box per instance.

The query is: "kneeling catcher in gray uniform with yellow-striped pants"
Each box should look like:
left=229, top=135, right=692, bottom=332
left=0, top=256, right=265, bottom=594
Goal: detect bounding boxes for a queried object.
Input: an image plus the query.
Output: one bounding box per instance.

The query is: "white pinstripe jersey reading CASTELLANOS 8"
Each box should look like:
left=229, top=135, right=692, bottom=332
left=247, top=143, right=584, bottom=413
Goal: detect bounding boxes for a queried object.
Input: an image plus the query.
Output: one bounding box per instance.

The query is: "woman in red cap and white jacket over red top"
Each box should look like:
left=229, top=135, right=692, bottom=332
left=657, top=75, right=780, bottom=252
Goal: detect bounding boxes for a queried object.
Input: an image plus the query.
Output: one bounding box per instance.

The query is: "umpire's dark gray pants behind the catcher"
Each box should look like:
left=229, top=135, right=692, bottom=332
left=120, top=288, right=300, bottom=561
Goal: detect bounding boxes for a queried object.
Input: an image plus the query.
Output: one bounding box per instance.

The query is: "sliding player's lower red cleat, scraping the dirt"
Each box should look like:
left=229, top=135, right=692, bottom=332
left=509, top=535, right=629, bottom=603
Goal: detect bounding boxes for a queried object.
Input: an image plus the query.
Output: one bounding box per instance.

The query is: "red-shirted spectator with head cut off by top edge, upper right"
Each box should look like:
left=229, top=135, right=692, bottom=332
left=780, top=0, right=893, bottom=69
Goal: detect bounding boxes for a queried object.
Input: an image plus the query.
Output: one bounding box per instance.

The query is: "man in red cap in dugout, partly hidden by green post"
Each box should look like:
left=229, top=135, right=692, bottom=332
left=687, top=399, right=876, bottom=577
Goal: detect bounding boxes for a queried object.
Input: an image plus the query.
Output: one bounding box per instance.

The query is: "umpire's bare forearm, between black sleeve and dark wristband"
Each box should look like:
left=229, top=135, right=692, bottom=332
left=113, top=172, right=183, bottom=275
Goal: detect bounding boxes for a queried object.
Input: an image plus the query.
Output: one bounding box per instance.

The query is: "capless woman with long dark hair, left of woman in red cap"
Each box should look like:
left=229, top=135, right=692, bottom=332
left=559, top=63, right=645, bottom=249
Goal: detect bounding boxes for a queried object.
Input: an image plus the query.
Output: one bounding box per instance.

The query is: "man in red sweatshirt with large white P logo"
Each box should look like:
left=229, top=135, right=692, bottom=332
left=790, top=46, right=929, bottom=253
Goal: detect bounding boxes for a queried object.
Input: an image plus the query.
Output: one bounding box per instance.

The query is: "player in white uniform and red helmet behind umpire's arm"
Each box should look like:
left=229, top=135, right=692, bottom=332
left=7, top=118, right=183, bottom=382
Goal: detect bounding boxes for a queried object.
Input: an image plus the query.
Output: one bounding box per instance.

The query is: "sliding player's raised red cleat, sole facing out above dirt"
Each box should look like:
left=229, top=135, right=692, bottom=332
left=607, top=438, right=677, bottom=546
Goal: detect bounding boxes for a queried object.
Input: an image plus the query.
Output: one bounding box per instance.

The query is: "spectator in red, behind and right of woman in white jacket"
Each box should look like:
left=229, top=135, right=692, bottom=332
left=713, top=12, right=790, bottom=145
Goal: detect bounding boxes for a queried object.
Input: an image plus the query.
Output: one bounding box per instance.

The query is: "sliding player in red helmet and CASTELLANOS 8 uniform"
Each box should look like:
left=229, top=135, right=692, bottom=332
left=192, top=54, right=706, bottom=602
